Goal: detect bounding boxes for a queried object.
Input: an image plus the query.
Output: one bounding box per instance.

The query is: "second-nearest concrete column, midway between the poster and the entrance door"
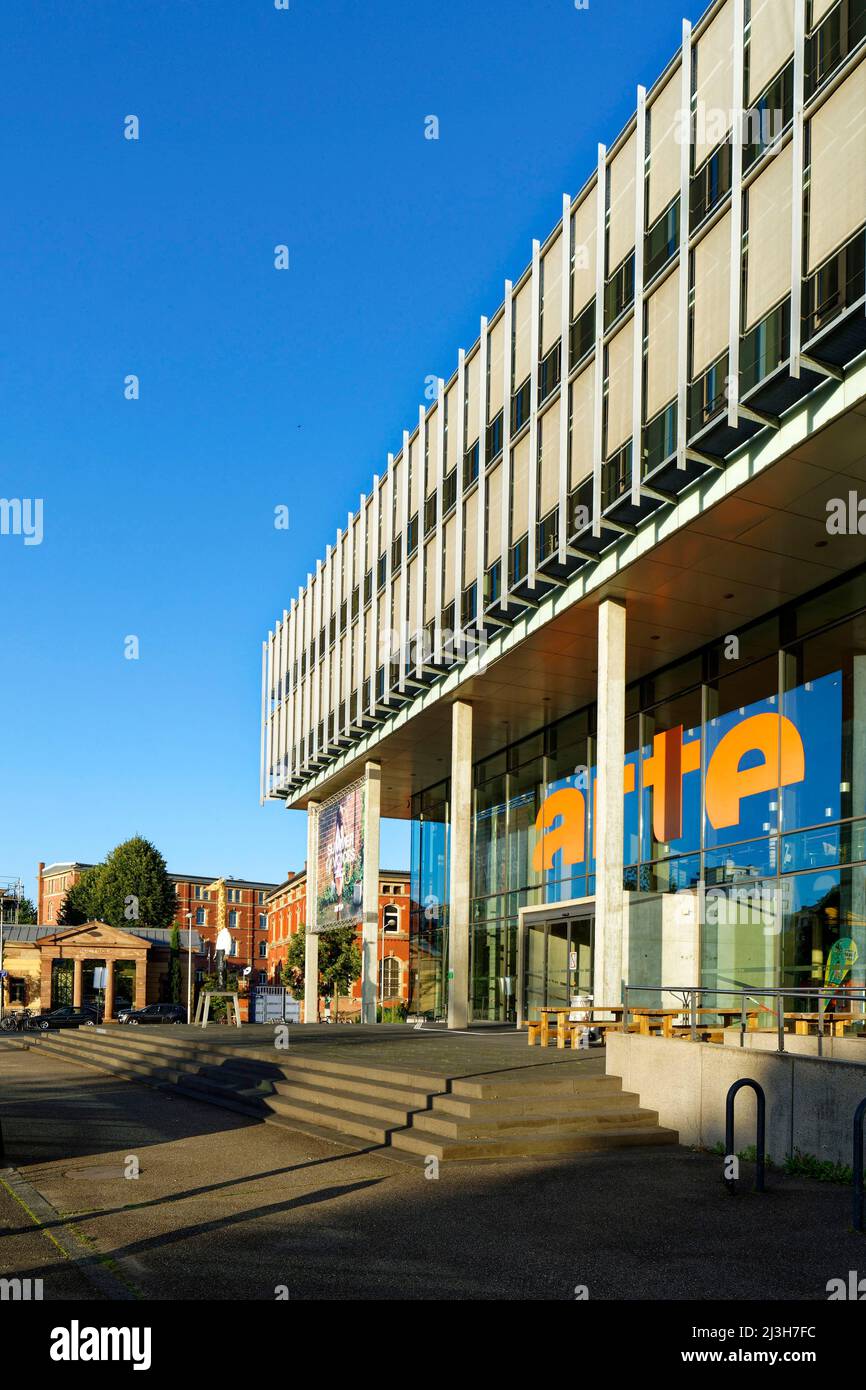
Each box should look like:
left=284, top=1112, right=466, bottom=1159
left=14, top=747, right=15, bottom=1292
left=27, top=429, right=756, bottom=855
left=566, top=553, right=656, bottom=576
left=448, top=701, right=473, bottom=1029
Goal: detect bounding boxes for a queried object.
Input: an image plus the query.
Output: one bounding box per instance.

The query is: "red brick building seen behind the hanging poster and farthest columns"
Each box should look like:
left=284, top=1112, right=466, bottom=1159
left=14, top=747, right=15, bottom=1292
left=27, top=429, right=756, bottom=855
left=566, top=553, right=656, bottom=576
left=265, top=869, right=411, bottom=1011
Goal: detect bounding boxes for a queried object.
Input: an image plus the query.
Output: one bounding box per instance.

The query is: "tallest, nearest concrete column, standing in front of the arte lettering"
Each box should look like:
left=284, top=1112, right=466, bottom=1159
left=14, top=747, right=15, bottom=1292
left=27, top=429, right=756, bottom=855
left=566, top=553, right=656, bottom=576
left=592, top=599, right=626, bottom=1004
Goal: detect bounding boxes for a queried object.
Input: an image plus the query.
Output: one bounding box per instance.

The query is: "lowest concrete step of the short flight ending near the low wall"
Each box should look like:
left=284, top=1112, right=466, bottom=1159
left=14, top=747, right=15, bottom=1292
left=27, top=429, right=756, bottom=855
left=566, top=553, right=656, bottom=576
left=391, top=1125, right=678, bottom=1163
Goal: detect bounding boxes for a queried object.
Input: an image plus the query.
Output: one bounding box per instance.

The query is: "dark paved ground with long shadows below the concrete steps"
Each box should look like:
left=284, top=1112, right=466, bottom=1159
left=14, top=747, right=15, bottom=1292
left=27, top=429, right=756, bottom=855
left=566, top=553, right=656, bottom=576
left=0, top=1043, right=866, bottom=1300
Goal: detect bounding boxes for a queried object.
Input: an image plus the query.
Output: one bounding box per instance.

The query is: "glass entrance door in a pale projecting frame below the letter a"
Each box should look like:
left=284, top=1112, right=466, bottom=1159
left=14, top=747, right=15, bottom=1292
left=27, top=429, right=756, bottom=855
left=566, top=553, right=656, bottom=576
left=517, top=898, right=595, bottom=1024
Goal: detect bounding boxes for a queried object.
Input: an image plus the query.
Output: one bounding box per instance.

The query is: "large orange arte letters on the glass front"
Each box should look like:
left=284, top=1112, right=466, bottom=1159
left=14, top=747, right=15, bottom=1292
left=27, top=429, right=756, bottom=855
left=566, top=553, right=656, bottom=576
left=532, top=712, right=806, bottom=873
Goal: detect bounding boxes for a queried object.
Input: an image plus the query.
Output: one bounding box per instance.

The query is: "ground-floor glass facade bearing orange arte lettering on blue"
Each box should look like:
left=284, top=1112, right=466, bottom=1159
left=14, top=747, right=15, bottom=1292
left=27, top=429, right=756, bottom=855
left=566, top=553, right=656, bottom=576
left=411, top=571, right=866, bottom=1020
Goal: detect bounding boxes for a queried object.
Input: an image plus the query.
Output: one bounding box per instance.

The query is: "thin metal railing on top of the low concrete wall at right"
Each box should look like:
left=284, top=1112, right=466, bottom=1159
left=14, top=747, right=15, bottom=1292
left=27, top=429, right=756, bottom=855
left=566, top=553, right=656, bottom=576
left=623, top=984, right=866, bottom=1056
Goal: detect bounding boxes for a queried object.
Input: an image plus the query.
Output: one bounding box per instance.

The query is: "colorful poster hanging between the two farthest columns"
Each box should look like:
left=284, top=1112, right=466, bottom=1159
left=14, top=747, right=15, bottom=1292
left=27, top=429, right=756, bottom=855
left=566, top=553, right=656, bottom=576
left=316, top=780, right=364, bottom=931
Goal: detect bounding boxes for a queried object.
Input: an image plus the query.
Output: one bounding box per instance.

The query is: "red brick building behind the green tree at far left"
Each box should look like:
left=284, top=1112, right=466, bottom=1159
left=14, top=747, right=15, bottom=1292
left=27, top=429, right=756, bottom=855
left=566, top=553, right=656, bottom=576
left=36, top=863, right=277, bottom=984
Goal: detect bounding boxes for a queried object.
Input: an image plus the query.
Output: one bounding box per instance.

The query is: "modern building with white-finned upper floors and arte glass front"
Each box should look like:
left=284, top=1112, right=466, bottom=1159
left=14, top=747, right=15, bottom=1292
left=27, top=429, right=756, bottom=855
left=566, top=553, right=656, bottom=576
left=261, top=0, right=866, bottom=1023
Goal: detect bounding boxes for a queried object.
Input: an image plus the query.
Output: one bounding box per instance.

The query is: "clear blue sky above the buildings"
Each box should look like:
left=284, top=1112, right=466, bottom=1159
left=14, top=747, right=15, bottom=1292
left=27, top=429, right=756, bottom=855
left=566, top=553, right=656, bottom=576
left=0, top=0, right=703, bottom=911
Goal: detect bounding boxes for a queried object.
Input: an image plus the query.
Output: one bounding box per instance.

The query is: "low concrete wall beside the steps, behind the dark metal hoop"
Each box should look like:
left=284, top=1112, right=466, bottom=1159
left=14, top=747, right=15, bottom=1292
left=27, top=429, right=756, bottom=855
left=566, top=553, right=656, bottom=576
left=606, top=1033, right=866, bottom=1163
